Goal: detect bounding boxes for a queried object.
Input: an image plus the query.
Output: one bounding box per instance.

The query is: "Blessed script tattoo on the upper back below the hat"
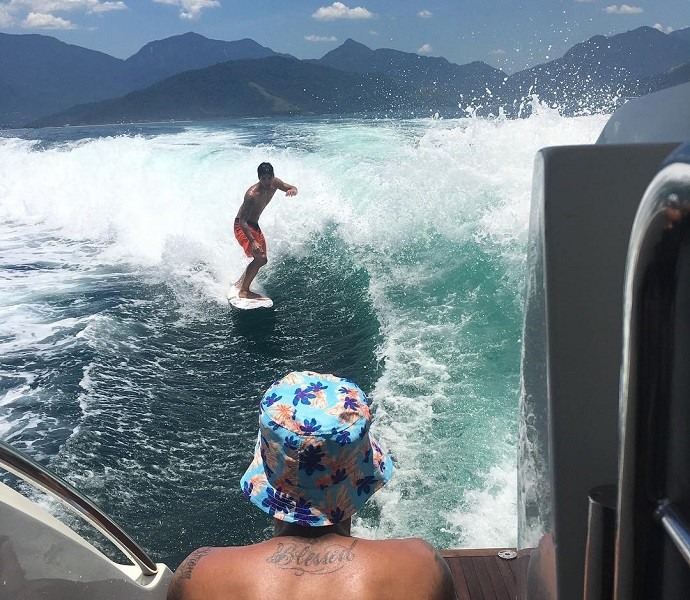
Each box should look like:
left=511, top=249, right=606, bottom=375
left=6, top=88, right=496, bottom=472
left=266, top=540, right=357, bottom=575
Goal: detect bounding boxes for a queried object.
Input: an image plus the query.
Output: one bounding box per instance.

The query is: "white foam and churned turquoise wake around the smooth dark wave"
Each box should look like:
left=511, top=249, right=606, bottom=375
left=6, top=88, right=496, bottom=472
left=0, top=110, right=605, bottom=547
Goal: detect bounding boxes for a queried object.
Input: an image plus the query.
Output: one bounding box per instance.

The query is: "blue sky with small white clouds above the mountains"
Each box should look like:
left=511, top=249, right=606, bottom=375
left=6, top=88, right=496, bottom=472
left=0, top=0, right=690, bottom=73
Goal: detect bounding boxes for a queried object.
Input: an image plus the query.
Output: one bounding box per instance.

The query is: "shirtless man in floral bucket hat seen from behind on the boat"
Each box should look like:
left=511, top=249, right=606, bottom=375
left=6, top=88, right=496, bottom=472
left=167, top=372, right=456, bottom=600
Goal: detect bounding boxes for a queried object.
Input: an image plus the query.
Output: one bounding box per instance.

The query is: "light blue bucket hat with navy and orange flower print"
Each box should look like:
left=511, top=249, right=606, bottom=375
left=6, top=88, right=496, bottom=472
left=240, top=371, right=393, bottom=527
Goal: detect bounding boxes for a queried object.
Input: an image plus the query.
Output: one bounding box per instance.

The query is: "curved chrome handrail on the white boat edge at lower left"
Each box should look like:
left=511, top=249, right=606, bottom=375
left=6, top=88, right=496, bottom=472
left=0, top=440, right=158, bottom=575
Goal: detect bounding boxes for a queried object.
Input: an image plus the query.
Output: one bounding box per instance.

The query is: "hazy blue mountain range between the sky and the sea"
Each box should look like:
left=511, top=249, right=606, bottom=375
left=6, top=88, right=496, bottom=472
left=0, top=27, right=690, bottom=127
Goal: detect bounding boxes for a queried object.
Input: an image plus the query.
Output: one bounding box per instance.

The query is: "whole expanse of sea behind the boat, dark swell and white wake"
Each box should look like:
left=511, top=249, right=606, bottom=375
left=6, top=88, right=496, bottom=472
left=0, top=104, right=606, bottom=568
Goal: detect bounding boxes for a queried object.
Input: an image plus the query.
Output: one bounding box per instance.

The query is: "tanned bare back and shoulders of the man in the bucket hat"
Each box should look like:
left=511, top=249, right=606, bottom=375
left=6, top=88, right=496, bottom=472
left=168, top=534, right=456, bottom=600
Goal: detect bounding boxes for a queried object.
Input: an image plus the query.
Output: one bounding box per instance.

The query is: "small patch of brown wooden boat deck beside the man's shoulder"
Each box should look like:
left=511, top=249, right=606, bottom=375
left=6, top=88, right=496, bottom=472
left=441, top=548, right=529, bottom=600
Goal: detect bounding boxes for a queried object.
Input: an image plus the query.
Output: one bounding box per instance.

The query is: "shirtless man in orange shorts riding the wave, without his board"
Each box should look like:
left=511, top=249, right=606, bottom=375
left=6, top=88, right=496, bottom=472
left=235, top=163, right=297, bottom=298
